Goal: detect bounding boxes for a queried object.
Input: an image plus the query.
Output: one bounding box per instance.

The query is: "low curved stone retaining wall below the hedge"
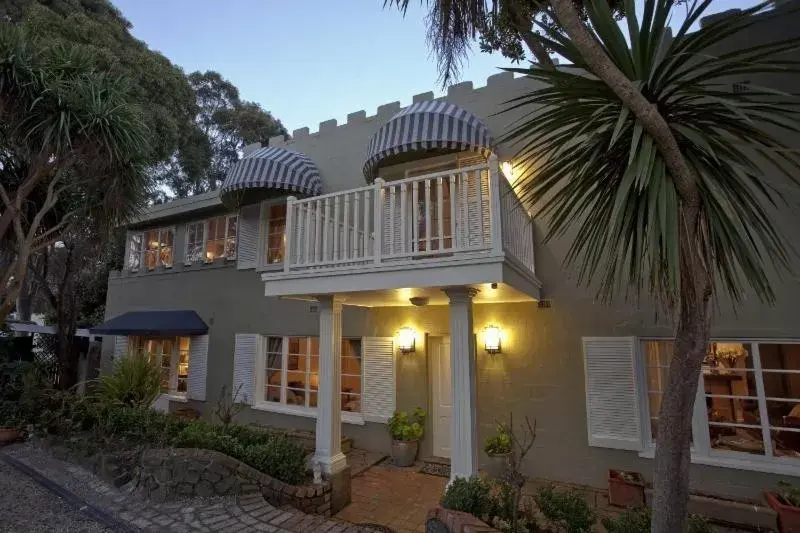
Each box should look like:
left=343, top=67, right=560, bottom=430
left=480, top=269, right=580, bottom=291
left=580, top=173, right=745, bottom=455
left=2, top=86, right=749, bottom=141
left=137, top=448, right=331, bottom=516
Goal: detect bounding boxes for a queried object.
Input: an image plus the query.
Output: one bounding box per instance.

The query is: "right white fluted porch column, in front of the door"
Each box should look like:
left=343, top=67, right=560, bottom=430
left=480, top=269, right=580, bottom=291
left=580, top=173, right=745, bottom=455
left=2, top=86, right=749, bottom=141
left=444, top=287, right=478, bottom=481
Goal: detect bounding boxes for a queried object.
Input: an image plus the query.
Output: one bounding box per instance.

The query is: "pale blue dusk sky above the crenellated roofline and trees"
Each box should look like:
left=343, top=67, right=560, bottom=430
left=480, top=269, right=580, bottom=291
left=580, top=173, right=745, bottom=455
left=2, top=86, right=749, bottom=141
left=113, top=0, right=754, bottom=133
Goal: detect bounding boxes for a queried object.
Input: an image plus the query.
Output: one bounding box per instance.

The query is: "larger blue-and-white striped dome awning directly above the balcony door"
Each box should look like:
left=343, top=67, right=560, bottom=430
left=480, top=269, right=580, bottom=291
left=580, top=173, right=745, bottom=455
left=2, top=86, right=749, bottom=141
left=364, top=100, right=494, bottom=180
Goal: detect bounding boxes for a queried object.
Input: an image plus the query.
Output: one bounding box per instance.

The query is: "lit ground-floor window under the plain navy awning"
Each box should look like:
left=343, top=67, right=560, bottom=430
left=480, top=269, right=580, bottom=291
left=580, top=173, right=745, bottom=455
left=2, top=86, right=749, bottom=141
left=129, top=337, right=189, bottom=395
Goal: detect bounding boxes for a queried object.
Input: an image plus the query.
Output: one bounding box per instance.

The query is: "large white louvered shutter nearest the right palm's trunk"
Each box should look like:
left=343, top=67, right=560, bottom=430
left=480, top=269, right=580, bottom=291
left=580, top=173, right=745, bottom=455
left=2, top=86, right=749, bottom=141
left=583, top=337, right=642, bottom=450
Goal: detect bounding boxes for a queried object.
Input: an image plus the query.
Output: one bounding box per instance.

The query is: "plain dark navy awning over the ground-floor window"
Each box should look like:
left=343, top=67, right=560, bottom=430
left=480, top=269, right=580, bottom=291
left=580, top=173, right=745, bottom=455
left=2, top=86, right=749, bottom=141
left=89, top=309, right=208, bottom=335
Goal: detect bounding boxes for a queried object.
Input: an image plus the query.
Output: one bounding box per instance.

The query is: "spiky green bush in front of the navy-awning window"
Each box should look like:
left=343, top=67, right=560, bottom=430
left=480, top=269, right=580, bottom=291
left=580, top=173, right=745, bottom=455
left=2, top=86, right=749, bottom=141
left=96, top=356, right=161, bottom=408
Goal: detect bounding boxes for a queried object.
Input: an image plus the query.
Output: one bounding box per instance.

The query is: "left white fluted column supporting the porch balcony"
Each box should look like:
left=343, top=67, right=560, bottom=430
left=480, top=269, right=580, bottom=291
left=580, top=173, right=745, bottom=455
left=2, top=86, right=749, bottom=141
left=314, top=296, right=347, bottom=474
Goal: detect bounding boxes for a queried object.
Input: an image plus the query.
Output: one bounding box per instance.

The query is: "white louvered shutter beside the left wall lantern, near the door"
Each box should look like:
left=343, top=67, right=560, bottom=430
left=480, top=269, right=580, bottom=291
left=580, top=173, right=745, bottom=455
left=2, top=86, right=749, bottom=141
left=361, top=337, right=395, bottom=423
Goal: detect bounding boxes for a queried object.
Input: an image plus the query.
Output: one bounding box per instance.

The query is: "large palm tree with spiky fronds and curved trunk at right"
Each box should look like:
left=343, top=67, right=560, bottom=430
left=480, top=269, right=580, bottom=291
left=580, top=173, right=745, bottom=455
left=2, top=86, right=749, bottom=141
left=390, top=0, right=800, bottom=533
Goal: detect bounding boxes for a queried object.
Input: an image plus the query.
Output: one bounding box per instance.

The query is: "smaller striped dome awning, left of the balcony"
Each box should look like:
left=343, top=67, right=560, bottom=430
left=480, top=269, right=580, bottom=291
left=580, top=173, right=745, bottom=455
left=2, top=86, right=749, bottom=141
left=220, top=146, right=322, bottom=200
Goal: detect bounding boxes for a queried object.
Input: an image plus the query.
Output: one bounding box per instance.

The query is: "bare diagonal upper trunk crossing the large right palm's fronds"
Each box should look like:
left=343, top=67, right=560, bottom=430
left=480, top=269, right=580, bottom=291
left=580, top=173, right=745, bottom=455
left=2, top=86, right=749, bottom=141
left=550, top=0, right=700, bottom=209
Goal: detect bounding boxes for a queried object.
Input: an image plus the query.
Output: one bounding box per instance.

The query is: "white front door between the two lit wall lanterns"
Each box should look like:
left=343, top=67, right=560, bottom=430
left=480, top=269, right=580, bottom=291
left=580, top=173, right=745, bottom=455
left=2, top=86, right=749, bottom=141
left=428, top=337, right=453, bottom=457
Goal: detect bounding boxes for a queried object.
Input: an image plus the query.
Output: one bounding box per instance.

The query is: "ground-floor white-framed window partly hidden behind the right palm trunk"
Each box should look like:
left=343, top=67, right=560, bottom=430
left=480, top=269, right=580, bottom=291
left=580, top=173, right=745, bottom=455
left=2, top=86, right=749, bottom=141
left=642, top=340, right=800, bottom=460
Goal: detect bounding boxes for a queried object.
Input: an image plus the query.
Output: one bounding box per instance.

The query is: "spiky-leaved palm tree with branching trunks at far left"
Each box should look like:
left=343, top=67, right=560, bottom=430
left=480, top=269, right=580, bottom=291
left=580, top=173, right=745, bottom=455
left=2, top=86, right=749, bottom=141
left=0, top=22, right=148, bottom=324
